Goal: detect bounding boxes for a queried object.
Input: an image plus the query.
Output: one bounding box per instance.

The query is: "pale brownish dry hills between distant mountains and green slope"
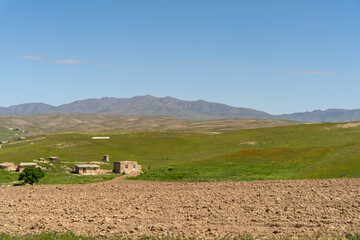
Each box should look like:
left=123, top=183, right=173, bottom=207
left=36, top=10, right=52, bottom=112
left=0, top=113, right=299, bottom=134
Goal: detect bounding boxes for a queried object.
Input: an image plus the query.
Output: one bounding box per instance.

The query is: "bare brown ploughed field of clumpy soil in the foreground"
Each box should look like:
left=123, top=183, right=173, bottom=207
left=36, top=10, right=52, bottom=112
left=0, top=179, right=360, bottom=238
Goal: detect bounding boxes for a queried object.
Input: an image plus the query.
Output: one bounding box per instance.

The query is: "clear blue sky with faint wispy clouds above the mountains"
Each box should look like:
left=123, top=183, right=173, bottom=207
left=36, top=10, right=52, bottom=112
left=0, top=0, right=360, bottom=114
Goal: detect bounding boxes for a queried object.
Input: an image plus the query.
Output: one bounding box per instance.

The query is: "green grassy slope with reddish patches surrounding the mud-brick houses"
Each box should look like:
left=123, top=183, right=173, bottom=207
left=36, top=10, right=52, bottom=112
left=0, top=124, right=360, bottom=184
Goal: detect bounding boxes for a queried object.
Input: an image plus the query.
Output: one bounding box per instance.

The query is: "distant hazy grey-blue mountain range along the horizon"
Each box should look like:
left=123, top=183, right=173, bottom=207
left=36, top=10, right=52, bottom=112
left=0, top=95, right=360, bottom=122
